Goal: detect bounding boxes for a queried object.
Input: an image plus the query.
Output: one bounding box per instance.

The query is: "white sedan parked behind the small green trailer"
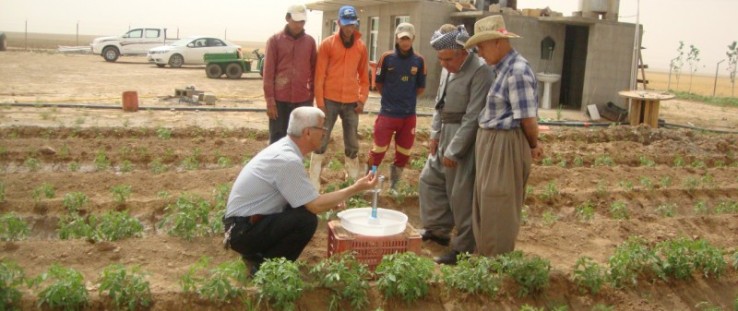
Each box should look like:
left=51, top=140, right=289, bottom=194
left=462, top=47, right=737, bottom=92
left=147, top=37, right=241, bottom=68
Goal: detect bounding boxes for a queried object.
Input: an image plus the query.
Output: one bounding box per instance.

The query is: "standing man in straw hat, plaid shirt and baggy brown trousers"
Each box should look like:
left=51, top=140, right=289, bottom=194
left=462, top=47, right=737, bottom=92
left=464, top=15, right=543, bottom=257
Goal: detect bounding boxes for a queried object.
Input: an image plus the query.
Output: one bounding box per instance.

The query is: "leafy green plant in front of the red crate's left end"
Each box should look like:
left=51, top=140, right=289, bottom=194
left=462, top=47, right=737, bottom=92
left=310, top=252, right=370, bottom=310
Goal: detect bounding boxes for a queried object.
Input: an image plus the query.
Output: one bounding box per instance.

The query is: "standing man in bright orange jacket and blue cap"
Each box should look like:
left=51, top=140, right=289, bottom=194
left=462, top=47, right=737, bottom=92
left=310, top=5, right=369, bottom=189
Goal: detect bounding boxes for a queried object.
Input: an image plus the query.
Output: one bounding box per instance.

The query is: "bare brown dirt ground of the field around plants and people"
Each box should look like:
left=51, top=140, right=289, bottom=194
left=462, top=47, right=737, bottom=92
left=0, top=47, right=738, bottom=310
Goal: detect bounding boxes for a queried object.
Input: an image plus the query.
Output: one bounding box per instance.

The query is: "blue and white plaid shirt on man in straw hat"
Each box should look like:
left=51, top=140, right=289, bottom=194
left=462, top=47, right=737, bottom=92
left=479, top=50, right=538, bottom=130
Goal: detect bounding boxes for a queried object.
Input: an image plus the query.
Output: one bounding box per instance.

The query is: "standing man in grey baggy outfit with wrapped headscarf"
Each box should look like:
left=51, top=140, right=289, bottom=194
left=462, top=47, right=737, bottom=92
left=418, top=24, right=493, bottom=264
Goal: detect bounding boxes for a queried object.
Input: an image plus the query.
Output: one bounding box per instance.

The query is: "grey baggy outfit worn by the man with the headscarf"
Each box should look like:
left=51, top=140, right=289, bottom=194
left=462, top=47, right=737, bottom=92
left=418, top=53, right=494, bottom=252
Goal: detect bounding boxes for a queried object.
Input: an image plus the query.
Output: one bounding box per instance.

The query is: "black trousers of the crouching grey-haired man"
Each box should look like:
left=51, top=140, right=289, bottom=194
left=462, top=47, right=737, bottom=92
left=225, top=206, right=318, bottom=265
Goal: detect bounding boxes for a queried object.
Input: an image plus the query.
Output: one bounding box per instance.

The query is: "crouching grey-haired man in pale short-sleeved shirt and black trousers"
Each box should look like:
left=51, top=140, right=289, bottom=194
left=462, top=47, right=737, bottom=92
left=223, top=107, right=378, bottom=275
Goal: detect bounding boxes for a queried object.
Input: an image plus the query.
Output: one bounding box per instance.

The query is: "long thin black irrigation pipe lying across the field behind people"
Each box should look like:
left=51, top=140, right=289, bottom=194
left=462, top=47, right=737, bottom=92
left=7, top=103, right=738, bottom=134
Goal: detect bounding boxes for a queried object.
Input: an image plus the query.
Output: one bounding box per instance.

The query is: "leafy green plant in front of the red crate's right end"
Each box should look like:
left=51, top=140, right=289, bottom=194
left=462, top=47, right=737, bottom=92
left=375, top=252, right=435, bottom=303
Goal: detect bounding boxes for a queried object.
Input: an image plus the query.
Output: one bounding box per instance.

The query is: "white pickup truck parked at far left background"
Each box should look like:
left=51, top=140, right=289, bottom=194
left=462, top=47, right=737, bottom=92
left=90, top=28, right=173, bottom=62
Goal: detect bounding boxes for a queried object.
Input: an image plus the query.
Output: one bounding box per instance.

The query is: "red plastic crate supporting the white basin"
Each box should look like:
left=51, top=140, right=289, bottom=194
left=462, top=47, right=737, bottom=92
left=328, top=220, right=422, bottom=271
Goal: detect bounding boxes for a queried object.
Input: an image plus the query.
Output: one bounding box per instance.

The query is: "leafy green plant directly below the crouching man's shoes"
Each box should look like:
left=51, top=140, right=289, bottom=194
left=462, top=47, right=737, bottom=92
left=254, top=258, right=305, bottom=310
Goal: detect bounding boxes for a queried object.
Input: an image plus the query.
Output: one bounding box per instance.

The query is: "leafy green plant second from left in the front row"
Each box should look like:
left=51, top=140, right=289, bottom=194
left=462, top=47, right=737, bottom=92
left=35, top=264, right=88, bottom=310
